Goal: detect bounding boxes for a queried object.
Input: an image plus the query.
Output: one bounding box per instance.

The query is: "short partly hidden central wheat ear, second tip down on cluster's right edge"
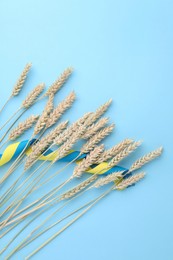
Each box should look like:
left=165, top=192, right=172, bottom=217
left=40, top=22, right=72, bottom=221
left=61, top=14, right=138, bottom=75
left=82, top=117, right=109, bottom=139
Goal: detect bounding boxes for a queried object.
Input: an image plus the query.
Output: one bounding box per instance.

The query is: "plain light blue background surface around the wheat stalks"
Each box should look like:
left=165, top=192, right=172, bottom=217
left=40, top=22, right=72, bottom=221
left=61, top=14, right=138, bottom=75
left=0, top=0, right=173, bottom=260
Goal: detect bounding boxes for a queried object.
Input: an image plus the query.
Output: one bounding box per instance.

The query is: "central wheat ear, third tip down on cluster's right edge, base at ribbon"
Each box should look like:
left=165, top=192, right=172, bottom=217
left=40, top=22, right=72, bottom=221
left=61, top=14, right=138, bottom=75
left=81, top=124, right=114, bottom=153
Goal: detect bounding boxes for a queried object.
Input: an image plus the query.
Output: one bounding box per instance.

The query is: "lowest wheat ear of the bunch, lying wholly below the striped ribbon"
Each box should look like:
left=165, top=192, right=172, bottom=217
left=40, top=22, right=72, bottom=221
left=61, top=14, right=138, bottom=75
left=60, top=174, right=97, bottom=200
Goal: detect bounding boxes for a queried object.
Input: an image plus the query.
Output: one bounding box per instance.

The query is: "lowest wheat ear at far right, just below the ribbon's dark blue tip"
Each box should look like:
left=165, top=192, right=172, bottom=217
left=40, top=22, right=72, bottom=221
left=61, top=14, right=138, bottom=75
left=115, top=172, right=145, bottom=190
